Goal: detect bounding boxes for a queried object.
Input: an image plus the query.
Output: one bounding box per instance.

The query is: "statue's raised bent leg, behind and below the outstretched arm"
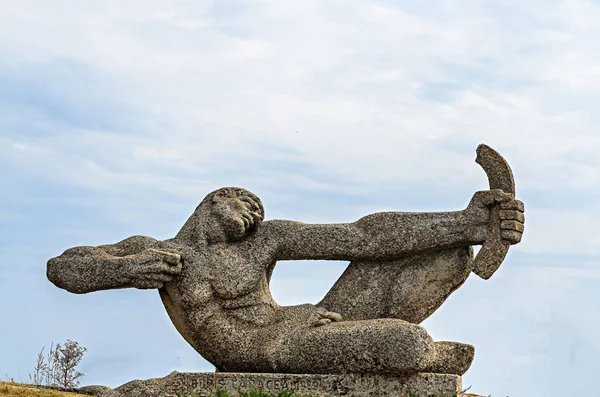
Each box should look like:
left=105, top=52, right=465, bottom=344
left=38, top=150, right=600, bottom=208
left=317, top=247, right=473, bottom=324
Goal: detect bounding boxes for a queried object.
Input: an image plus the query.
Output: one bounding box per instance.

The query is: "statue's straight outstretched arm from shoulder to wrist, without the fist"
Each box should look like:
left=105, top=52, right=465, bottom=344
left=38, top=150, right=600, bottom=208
left=271, top=211, right=487, bottom=260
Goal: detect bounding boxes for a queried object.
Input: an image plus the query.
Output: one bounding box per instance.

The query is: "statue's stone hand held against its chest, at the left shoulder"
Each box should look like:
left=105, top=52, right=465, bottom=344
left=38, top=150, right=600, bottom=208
left=123, top=248, right=182, bottom=289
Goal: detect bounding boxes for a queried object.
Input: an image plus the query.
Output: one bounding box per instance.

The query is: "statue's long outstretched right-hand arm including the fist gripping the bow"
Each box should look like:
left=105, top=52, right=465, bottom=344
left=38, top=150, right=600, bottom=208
left=266, top=190, right=525, bottom=260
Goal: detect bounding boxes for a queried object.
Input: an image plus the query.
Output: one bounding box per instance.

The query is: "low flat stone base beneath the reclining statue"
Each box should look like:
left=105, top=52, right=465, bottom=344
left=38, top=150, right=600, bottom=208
left=102, top=371, right=462, bottom=397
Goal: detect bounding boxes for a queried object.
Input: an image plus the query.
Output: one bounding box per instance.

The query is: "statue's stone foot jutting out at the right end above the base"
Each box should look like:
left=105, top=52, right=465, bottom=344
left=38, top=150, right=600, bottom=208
left=423, top=342, right=475, bottom=375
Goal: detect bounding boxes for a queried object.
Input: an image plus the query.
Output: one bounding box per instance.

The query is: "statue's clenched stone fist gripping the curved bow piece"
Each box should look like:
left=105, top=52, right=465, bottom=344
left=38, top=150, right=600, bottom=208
left=465, top=189, right=525, bottom=244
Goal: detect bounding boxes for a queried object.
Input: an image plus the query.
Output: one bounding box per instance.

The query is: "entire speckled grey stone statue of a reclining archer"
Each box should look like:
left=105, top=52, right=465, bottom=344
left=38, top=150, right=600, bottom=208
left=47, top=146, right=524, bottom=375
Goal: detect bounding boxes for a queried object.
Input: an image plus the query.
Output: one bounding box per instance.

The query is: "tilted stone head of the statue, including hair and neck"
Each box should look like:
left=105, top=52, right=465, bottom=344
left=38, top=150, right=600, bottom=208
left=177, top=187, right=265, bottom=242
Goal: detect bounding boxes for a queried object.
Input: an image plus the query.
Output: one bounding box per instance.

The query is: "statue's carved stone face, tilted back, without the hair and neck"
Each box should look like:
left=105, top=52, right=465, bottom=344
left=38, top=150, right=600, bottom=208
left=211, top=195, right=262, bottom=241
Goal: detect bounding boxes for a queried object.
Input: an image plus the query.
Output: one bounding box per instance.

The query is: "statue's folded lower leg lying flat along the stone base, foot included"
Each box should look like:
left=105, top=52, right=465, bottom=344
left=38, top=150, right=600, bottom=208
left=268, top=319, right=474, bottom=375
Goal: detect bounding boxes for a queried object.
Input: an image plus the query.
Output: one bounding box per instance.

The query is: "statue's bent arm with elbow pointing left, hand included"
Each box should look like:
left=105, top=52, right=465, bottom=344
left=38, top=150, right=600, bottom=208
left=46, top=236, right=181, bottom=294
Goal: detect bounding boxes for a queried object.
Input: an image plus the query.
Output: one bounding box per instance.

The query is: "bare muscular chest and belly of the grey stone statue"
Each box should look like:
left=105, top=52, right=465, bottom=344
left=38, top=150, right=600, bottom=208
left=161, top=237, right=277, bottom=339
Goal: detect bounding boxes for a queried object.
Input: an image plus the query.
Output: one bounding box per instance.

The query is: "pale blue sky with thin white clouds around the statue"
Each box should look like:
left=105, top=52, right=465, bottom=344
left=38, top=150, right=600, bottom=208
left=0, top=0, right=600, bottom=397
